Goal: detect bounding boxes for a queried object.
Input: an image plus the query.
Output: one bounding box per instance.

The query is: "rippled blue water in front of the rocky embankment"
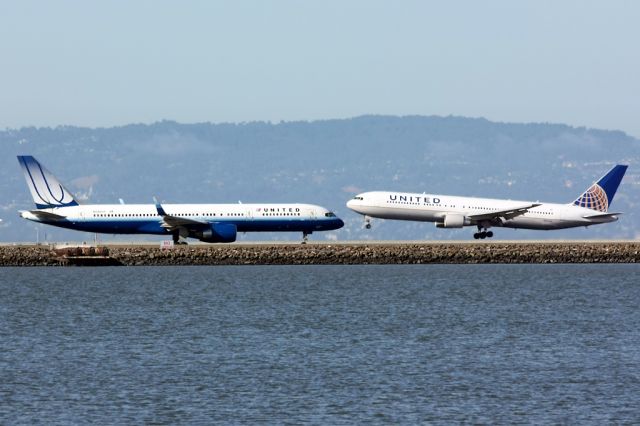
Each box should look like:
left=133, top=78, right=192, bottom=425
left=0, top=265, right=640, bottom=424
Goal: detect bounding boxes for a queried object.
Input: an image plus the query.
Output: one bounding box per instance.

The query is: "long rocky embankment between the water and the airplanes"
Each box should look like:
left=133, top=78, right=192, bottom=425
left=0, top=242, right=640, bottom=266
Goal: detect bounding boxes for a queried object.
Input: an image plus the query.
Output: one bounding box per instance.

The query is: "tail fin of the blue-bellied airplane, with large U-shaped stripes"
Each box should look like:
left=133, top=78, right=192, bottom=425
left=18, top=155, right=78, bottom=209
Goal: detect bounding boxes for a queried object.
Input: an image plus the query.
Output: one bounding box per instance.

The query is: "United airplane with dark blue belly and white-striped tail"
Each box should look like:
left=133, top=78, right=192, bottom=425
left=18, top=155, right=344, bottom=243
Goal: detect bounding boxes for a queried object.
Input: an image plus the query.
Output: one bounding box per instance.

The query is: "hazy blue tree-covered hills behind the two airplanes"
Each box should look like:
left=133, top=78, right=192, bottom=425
left=0, top=116, right=640, bottom=241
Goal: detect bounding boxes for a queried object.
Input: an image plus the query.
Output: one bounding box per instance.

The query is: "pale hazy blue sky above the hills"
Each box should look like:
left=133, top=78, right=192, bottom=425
left=0, top=0, right=640, bottom=137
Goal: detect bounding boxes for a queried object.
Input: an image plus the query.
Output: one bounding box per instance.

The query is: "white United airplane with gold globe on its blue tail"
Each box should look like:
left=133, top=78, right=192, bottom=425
left=347, top=164, right=627, bottom=239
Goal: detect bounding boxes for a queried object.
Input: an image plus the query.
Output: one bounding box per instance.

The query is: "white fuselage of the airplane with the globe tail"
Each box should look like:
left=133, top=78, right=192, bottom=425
left=347, top=191, right=617, bottom=230
